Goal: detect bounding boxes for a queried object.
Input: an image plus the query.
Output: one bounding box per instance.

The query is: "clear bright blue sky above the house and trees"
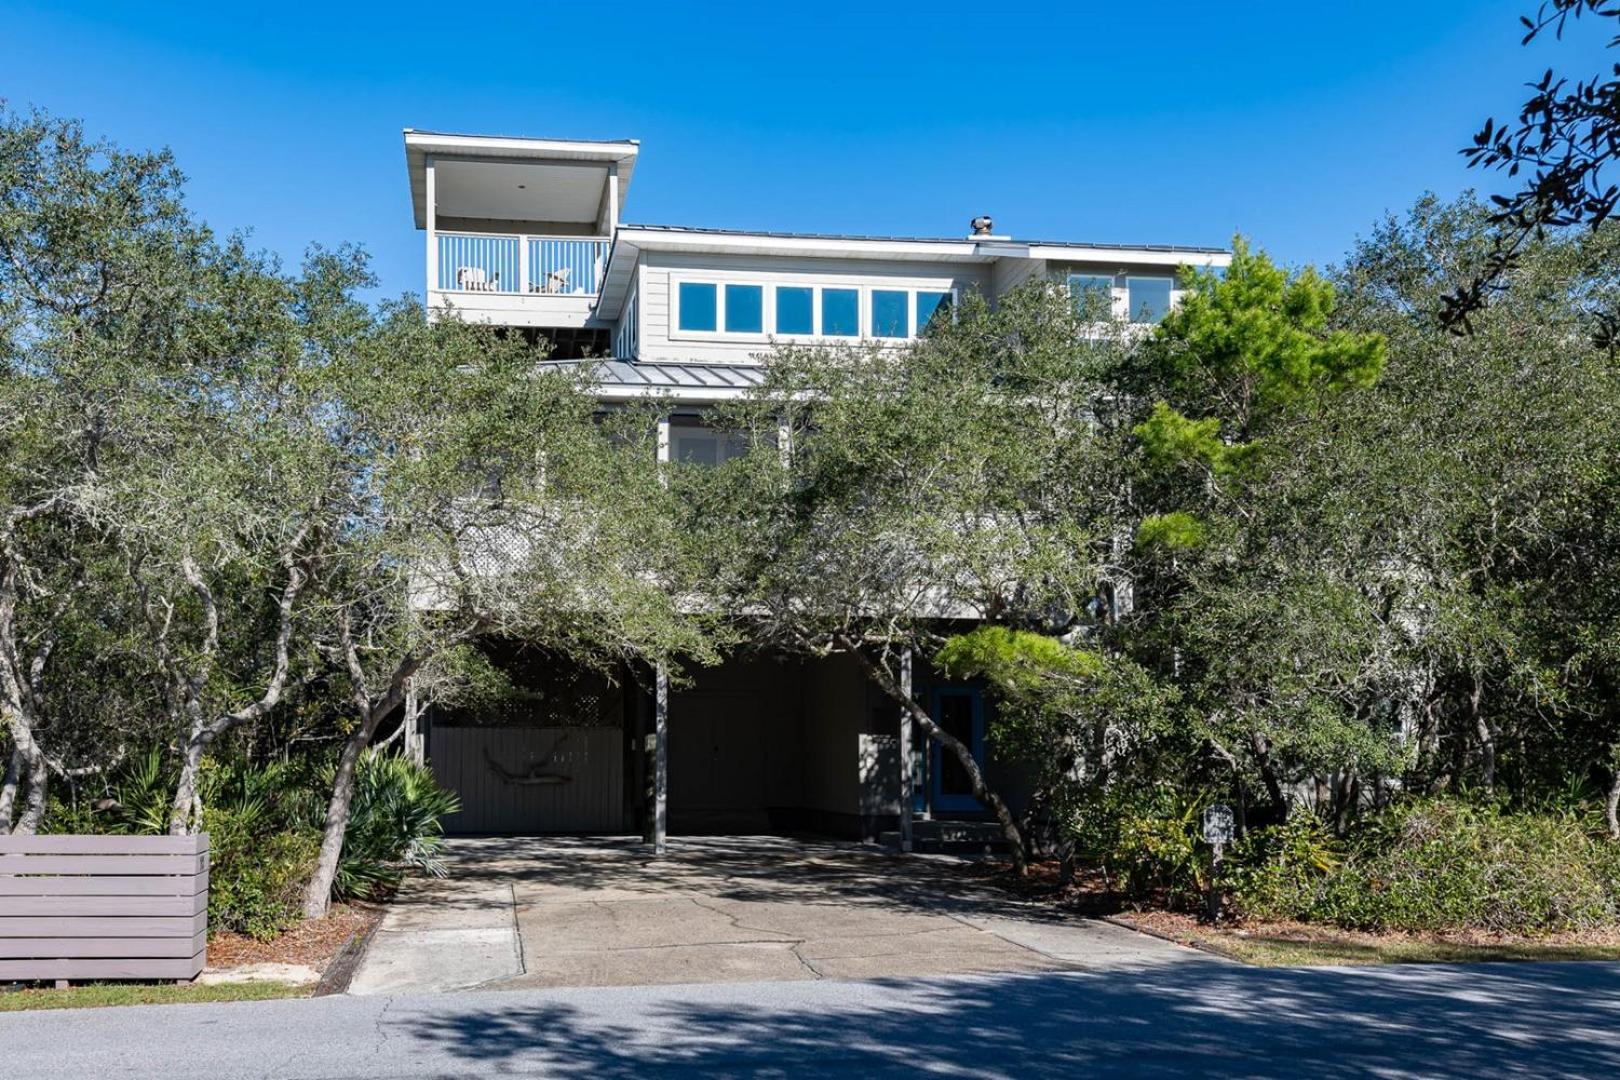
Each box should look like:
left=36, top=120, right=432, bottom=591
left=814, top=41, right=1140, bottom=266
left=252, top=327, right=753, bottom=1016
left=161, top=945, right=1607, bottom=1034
left=0, top=0, right=1605, bottom=302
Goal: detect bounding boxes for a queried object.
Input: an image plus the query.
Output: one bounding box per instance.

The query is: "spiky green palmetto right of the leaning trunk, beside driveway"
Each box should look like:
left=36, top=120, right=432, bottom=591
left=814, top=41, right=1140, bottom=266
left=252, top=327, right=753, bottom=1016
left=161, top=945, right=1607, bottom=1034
left=335, top=751, right=460, bottom=900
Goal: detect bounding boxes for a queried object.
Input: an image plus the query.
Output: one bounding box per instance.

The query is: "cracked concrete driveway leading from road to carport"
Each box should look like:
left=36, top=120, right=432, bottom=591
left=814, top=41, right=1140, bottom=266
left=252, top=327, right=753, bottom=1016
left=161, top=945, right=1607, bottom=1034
left=350, top=837, right=1213, bottom=994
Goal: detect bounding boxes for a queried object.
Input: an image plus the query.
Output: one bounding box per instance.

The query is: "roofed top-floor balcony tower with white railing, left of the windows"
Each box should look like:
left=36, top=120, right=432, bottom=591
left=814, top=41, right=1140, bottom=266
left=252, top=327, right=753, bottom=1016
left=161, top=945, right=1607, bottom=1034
left=405, top=130, right=640, bottom=329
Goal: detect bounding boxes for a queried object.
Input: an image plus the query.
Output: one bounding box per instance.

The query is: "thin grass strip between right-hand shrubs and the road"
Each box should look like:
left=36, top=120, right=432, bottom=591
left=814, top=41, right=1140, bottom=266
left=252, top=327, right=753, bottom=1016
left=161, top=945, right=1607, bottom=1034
left=1119, top=912, right=1620, bottom=967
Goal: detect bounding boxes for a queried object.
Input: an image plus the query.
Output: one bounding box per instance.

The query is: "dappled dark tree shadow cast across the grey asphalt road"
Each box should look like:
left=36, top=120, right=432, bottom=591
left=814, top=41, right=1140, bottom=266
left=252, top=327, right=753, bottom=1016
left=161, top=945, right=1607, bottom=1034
left=410, top=963, right=1620, bottom=1078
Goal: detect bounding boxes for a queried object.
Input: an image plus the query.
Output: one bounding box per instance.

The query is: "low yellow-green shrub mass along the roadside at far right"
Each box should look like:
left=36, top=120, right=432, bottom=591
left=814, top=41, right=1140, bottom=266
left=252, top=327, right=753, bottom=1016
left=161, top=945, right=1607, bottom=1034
left=1234, top=800, right=1620, bottom=933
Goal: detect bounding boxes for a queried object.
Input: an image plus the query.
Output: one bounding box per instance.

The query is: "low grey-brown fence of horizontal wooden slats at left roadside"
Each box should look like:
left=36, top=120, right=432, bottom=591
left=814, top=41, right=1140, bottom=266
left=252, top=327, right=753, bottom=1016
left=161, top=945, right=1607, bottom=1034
left=0, top=834, right=207, bottom=981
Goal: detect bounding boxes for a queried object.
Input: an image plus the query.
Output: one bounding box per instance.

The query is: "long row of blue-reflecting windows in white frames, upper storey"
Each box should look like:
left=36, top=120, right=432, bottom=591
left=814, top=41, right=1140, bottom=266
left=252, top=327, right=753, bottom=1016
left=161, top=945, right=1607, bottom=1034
left=676, top=282, right=951, bottom=338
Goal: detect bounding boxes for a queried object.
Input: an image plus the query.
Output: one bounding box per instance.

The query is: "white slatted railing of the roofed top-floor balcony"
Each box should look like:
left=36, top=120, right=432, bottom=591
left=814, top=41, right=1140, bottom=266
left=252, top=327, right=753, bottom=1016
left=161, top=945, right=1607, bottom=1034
left=437, top=233, right=608, bottom=296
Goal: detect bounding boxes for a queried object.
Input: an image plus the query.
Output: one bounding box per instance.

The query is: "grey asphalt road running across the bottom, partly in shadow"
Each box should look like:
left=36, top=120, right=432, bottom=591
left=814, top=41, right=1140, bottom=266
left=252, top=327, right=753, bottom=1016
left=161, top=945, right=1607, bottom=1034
left=0, top=963, right=1620, bottom=1080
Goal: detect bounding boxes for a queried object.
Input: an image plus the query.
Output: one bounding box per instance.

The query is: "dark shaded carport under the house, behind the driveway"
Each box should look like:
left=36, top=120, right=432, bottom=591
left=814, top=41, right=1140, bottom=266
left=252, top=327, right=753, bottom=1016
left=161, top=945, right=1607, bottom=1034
left=424, top=644, right=1006, bottom=840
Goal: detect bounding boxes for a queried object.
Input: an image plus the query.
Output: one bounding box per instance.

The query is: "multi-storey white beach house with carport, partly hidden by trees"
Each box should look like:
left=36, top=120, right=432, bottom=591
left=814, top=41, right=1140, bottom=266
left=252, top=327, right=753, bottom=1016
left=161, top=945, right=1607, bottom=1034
left=405, top=130, right=1230, bottom=842
